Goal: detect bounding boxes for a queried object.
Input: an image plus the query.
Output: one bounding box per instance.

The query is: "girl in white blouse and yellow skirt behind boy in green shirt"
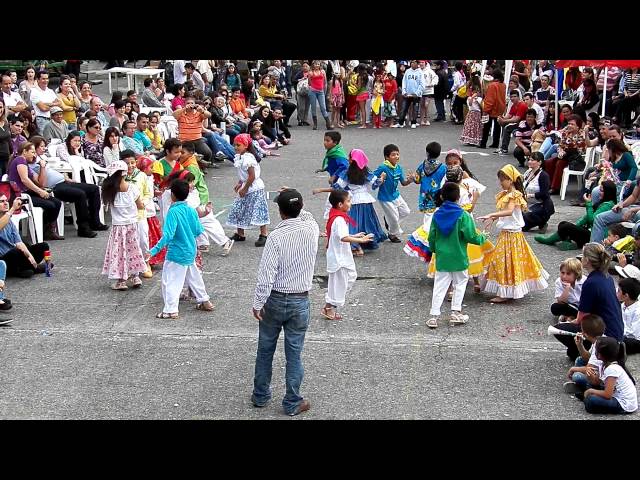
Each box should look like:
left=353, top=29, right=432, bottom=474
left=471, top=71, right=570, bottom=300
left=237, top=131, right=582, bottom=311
left=427, top=165, right=493, bottom=293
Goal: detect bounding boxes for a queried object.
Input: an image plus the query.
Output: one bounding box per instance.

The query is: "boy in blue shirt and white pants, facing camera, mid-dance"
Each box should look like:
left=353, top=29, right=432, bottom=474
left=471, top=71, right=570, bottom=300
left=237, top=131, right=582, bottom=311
left=373, top=143, right=414, bottom=243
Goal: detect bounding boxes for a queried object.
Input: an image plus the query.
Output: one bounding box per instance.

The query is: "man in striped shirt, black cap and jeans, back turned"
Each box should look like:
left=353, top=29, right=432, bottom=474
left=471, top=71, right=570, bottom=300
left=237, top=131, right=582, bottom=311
left=251, top=188, right=320, bottom=416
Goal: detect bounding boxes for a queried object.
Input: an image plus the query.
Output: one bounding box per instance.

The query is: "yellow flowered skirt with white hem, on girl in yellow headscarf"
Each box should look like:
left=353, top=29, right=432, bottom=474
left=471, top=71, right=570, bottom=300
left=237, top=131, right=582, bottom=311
left=480, top=230, right=549, bottom=298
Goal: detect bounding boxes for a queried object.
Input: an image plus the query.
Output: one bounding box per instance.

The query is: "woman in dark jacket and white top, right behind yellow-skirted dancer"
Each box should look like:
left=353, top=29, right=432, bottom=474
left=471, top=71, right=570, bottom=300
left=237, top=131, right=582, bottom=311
left=522, top=152, right=555, bottom=232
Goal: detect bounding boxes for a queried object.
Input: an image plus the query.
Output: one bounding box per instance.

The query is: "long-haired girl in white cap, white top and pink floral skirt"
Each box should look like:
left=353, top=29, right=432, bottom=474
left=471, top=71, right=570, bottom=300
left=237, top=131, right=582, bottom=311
left=102, top=160, right=147, bottom=290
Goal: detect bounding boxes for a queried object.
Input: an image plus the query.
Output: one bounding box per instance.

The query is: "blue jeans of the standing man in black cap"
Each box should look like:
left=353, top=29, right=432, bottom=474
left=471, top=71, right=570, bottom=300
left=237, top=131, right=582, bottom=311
left=251, top=292, right=311, bottom=415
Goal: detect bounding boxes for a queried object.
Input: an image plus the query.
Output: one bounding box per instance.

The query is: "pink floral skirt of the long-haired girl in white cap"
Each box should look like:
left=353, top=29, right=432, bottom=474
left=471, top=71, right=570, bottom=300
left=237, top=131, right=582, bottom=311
left=102, top=223, right=147, bottom=280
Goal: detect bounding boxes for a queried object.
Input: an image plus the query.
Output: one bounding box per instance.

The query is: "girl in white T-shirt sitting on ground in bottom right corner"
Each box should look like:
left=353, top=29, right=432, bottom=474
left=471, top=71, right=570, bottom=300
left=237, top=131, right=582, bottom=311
left=576, top=337, right=638, bottom=414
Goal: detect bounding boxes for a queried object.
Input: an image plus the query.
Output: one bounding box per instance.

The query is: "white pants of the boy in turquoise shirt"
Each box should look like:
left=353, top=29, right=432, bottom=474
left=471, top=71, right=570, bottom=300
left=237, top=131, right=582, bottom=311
left=162, top=260, right=209, bottom=313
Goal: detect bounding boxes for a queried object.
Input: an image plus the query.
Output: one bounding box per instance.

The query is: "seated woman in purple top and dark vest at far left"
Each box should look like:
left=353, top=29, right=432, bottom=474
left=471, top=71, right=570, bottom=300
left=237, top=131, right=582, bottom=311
left=5, top=142, right=64, bottom=240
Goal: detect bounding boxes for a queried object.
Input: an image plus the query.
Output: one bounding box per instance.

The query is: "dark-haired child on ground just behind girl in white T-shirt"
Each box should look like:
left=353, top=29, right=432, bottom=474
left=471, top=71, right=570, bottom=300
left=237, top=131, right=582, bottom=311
left=562, top=314, right=605, bottom=393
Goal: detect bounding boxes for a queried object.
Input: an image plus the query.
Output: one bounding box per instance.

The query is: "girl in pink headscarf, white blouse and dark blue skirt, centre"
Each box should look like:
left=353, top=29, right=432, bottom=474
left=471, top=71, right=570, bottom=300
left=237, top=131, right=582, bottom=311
left=313, top=148, right=387, bottom=257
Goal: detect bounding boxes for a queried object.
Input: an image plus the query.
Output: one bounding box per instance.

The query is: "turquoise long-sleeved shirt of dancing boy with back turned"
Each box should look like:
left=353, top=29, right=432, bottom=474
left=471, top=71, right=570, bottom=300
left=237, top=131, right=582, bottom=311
left=151, top=201, right=204, bottom=267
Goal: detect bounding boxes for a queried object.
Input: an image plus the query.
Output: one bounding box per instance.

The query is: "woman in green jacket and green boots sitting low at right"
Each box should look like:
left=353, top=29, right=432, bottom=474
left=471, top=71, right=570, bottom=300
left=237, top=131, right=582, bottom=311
left=534, top=180, right=620, bottom=249
